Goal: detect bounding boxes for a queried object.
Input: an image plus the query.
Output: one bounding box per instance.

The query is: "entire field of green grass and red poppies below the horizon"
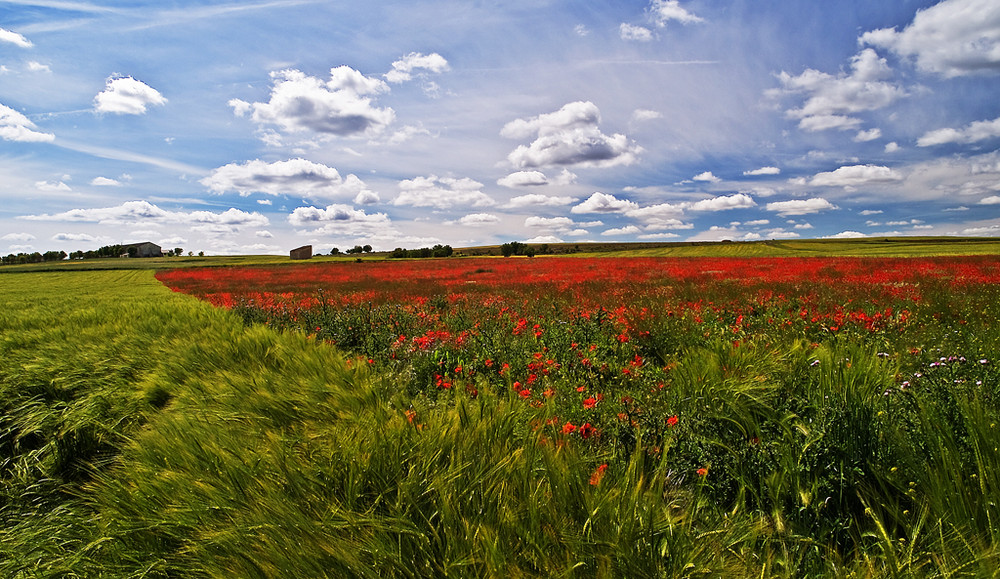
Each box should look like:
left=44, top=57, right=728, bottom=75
left=0, top=242, right=1000, bottom=577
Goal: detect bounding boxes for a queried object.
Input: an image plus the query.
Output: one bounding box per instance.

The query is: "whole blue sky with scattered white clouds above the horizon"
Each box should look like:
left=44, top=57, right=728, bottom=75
left=0, top=0, right=1000, bottom=255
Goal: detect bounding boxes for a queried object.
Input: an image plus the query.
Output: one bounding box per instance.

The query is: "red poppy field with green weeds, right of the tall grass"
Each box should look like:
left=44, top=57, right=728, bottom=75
left=158, top=257, right=1000, bottom=572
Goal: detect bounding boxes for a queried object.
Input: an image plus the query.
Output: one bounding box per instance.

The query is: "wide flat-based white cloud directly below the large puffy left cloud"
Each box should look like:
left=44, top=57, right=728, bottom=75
left=200, top=159, right=378, bottom=203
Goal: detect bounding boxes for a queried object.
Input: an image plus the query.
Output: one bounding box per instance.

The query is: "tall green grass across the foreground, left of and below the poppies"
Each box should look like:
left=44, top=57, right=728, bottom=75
left=0, top=262, right=1000, bottom=578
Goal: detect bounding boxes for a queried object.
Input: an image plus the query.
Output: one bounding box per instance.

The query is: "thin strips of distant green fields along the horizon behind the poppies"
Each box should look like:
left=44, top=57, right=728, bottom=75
left=0, top=237, right=1000, bottom=273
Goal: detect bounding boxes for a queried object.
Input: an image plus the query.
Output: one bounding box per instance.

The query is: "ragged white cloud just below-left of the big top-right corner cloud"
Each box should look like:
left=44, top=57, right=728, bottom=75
left=772, top=48, right=906, bottom=132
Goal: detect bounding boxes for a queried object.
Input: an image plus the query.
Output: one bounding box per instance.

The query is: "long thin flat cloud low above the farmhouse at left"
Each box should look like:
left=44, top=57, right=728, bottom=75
left=18, top=201, right=268, bottom=228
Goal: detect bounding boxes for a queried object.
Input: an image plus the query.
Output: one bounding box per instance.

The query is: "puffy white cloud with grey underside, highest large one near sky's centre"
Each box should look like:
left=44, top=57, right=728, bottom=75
left=500, top=101, right=642, bottom=169
